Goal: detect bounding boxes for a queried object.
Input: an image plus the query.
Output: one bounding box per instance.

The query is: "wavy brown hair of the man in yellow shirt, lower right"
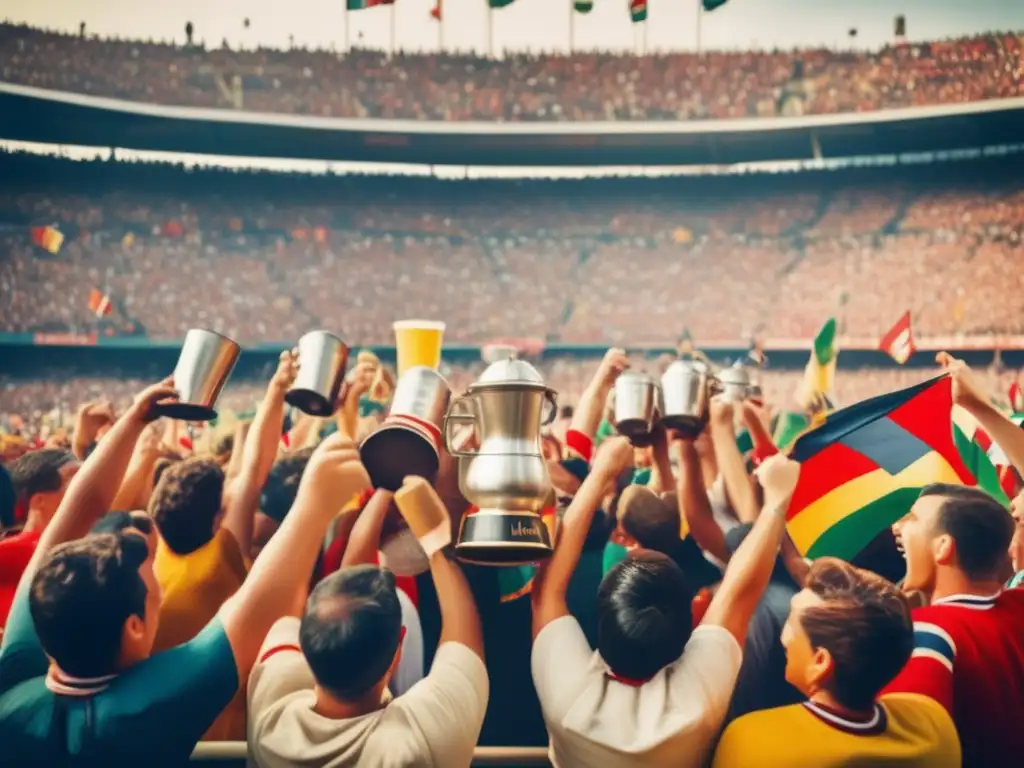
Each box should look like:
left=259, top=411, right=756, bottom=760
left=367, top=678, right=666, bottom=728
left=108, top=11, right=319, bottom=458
left=799, top=557, right=913, bottom=710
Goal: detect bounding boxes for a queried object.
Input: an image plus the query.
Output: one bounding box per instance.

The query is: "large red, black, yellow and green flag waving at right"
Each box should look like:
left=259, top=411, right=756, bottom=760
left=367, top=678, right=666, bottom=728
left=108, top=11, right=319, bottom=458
left=786, top=376, right=975, bottom=560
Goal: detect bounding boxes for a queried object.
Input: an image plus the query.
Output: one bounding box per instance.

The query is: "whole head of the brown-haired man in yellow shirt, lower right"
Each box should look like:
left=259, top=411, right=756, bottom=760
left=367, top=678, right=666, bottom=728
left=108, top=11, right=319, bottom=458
left=782, top=557, right=913, bottom=712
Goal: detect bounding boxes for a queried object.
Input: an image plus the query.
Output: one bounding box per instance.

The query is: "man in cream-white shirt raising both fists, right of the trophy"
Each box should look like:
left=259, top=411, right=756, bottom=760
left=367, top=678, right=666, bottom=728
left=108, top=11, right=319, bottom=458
left=532, top=438, right=800, bottom=768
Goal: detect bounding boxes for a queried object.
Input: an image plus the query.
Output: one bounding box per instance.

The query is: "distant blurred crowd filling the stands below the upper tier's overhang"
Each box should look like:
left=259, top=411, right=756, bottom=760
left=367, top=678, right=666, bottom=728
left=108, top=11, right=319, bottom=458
left=0, top=156, right=1024, bottom=345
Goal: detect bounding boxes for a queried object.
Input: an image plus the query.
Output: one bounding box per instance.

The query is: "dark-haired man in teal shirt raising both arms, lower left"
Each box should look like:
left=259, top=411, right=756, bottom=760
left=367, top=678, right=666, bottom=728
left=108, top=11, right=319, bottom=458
left=0, top=380, right=369, bottom=766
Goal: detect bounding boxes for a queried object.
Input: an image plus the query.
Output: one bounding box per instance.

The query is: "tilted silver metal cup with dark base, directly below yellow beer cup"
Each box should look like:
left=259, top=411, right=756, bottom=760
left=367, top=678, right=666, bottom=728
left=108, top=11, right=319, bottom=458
left=359, top=366, right=452, bottom=490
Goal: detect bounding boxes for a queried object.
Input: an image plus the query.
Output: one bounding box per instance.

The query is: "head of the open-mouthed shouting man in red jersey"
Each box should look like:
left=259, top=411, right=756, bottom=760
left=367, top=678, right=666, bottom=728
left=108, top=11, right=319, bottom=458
left=894, top=483, right=1014, bottom=593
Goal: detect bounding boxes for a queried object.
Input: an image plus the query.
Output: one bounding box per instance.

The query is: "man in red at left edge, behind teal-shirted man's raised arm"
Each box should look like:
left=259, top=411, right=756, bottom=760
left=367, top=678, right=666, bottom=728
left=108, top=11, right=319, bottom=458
left=0, top=449, right=78, bottom=627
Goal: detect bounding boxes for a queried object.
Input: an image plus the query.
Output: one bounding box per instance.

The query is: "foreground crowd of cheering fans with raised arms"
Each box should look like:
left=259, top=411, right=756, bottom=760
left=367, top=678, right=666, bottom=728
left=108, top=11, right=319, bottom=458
left=0, top=348, right=1024, bottom=768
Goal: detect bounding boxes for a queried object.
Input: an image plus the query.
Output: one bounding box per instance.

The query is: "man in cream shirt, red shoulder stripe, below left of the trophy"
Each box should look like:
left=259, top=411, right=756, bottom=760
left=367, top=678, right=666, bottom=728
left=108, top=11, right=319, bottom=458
left=249, top=532, right=488, bottom=768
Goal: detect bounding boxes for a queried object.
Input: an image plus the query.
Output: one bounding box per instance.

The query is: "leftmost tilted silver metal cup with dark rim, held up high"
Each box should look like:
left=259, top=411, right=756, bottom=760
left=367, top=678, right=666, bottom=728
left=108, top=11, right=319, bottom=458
left=157, top=328, right=242, bottom=421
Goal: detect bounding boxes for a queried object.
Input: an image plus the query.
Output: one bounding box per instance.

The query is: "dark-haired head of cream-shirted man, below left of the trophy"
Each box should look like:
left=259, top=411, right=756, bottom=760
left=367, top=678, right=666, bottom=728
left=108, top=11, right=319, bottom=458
left=299, top=565, right=401, bottom=701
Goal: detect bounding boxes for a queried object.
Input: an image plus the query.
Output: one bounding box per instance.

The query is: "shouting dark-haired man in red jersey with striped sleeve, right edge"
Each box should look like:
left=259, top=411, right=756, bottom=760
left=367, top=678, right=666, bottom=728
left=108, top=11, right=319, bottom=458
left=888, top=485, right=1024, bottom=767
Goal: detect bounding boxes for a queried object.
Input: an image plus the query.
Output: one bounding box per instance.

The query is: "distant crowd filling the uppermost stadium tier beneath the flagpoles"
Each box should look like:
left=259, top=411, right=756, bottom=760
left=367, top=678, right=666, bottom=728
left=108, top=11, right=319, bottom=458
left=0, top=25, right=1024, bottom=122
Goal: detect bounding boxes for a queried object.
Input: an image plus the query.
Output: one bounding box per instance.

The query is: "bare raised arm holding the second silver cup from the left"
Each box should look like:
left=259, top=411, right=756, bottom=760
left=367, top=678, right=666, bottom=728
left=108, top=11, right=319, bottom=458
left=221, top=350, right=298, bottom=554
